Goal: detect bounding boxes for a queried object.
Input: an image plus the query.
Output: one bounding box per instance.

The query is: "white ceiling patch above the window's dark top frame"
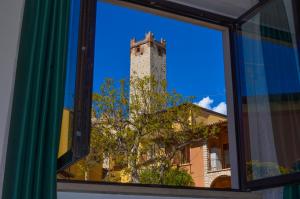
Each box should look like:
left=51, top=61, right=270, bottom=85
left=167, top=0, right=258, bottom=18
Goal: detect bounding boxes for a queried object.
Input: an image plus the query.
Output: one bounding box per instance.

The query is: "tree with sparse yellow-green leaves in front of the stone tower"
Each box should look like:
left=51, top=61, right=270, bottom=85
left=91, top=77, right=217, bottom=183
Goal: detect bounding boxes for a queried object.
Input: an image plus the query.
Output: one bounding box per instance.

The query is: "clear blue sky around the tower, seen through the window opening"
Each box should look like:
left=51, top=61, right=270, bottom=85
left=93, top=2, right=225, bottom=113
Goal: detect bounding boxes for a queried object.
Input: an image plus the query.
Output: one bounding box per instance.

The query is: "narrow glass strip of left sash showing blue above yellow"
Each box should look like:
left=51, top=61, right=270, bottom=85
left=58, top=0, right=80, bottom=157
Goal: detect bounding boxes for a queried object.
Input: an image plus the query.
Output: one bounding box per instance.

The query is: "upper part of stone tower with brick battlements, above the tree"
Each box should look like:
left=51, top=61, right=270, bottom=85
left=130, top=32, right=166, bottom=98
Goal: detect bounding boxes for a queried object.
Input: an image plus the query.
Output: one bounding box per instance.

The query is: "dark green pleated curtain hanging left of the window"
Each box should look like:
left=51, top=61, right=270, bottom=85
left=2, top=0, right=70, bottom=199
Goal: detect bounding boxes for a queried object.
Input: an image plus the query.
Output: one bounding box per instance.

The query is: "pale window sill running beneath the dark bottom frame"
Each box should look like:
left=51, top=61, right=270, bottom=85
left=57, top=180, right=262, bottom=199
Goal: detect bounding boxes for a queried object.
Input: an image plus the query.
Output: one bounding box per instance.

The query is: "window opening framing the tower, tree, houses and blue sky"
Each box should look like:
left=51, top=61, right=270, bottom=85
left=58, top=1, right=231, bottom=188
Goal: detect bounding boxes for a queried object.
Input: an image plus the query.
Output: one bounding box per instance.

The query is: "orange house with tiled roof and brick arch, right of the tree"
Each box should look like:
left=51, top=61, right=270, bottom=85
left=177, top=105, right=231, bottom=188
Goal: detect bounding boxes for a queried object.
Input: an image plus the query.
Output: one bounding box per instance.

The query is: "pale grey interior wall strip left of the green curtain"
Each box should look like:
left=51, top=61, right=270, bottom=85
left=0, top=0, right=24, bottom=198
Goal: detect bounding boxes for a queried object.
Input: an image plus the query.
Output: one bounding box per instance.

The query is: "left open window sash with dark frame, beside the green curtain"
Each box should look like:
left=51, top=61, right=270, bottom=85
left=57, top=0, right=96, bottom=172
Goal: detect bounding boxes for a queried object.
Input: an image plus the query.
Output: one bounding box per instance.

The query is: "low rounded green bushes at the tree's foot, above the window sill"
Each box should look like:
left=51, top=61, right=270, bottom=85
left=140, top=168, right=195, bottom=186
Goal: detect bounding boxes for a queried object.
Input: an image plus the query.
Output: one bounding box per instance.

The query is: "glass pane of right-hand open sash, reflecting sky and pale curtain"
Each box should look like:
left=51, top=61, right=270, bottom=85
left=238, top=0, right=300, bottom=181
